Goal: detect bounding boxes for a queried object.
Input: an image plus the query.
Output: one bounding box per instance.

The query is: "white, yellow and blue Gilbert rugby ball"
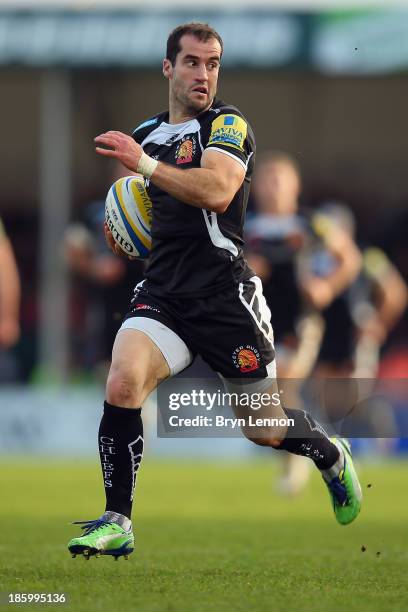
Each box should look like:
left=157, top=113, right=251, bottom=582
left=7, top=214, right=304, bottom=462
left=105, top=176, right=152, bottom=259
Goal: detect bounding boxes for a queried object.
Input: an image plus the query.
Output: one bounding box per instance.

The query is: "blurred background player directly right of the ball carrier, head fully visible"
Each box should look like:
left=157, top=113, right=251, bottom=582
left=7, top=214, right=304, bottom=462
left=246, top=151, right=361, bottom=494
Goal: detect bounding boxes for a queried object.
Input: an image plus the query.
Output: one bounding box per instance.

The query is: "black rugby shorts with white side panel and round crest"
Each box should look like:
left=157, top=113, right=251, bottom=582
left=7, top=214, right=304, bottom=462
left=124, top=277, right=275, bottom=382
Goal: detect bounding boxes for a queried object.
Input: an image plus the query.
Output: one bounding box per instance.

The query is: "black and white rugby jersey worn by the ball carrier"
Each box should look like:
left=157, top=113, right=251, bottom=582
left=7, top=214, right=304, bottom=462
left=133, top=100, right=255, bottom=297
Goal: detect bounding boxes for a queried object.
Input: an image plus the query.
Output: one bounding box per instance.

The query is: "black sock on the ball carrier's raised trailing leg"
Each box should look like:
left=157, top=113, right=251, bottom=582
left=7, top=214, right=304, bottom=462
left=278, top=408, right=340, bottom=470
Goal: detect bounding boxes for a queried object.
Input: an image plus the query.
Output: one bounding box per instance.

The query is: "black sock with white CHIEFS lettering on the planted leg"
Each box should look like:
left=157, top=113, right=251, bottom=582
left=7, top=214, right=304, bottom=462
left=98, top=402, right=143, bottom=518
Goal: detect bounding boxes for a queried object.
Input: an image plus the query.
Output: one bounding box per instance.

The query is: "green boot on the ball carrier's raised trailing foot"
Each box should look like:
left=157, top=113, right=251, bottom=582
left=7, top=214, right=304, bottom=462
left=323, top=438, right=363, bottom=525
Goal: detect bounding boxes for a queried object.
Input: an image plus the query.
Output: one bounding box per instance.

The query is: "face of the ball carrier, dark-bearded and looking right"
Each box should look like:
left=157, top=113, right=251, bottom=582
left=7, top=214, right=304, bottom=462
left=163, top=34, right=221, bottom=115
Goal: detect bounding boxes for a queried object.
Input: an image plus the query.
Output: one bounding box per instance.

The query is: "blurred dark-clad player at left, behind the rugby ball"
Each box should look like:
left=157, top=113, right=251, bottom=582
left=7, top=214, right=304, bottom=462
left=64, top=163, right=144, bottom=380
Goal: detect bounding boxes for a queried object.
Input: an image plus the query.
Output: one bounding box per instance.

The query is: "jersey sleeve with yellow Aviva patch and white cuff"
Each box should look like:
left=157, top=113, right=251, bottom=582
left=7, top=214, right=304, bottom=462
left=205, top=111, right=255, bottom=169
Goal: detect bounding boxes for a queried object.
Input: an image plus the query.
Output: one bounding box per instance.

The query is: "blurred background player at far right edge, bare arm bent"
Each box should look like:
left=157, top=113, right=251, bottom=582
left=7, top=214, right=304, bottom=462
left=315, top=202, right=407, bottom=450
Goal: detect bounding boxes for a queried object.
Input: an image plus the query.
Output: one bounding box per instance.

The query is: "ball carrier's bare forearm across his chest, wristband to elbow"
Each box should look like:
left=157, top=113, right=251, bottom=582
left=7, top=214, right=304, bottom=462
left=150, top=162, right=230, bottom=213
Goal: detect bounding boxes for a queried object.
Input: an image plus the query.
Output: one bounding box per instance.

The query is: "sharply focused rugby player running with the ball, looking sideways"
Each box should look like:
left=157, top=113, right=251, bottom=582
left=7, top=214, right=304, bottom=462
left=68, top=23, right=361, bottom=558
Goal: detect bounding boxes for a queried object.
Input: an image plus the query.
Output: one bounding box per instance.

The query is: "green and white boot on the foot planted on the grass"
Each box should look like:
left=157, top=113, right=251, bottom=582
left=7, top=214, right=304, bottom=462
left=68, top=512, right=135, bottom=561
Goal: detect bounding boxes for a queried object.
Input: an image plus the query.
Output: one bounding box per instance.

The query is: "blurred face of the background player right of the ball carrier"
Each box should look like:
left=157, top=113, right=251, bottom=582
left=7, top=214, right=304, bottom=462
left=254, top=162, right=300, bottom=216
